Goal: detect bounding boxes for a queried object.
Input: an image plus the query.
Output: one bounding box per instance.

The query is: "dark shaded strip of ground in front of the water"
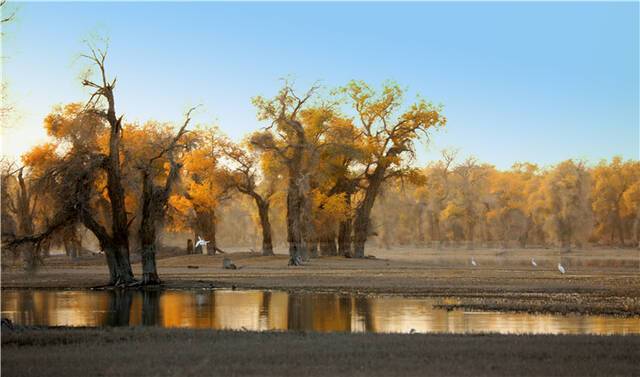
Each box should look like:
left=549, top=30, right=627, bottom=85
left=2, top=328, right=640, bottom=377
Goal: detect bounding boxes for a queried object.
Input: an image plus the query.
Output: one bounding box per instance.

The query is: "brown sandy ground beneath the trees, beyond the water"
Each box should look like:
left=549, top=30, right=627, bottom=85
left=2, top=248, right=640, bottom=316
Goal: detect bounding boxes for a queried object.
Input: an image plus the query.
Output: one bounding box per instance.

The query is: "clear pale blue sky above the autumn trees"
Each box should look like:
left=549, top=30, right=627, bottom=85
left=2, top=2, right=640, bottom=168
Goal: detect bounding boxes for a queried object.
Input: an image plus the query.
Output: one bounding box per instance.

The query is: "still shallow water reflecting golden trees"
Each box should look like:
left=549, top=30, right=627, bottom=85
left=2, top=290, right=640, bottom=334
